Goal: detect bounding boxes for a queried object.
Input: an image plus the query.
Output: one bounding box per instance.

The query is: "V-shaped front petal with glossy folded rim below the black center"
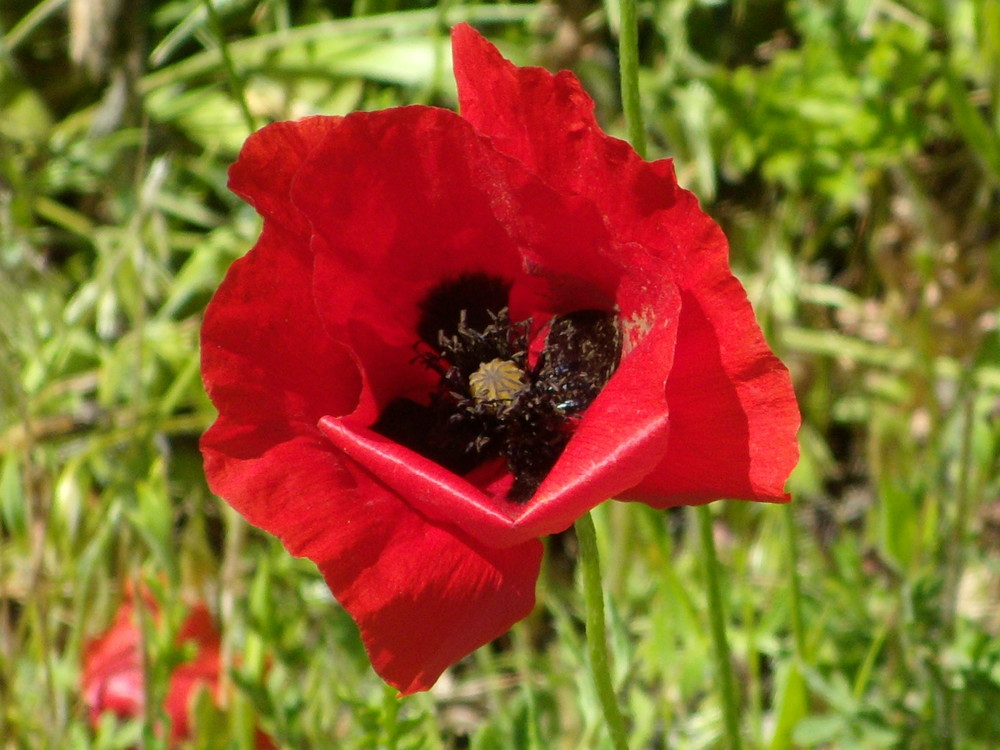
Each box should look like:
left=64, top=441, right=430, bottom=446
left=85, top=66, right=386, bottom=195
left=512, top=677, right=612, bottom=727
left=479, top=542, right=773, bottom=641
left=312, top=248, right=680, bottom=547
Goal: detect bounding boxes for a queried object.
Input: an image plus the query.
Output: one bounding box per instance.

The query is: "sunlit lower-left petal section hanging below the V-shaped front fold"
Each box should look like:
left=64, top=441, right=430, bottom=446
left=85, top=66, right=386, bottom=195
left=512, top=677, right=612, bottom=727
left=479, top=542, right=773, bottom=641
left=203, top=417, right=542, bottom=693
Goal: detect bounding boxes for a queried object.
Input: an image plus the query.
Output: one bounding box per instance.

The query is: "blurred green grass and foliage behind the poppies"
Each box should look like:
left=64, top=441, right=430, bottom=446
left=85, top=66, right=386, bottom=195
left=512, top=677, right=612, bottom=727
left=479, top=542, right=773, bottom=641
left=0, top=0, right=1000, bottom=750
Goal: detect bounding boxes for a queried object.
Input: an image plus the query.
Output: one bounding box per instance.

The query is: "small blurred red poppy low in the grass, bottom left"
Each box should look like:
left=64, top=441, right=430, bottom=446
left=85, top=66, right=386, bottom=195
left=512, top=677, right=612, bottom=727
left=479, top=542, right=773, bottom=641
left=82, top=595, right=274, bottom=750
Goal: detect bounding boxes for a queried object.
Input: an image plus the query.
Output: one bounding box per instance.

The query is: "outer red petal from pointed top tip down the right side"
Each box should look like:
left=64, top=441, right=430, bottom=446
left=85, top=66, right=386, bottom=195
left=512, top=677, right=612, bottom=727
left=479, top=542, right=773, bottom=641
left=453, top=25, right=799, bottom=507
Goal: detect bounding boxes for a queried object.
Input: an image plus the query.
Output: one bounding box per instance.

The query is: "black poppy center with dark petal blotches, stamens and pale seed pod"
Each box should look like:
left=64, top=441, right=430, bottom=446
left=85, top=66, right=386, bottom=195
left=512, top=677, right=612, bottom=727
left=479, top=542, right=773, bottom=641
left=374, top=274, right=621, bottom=502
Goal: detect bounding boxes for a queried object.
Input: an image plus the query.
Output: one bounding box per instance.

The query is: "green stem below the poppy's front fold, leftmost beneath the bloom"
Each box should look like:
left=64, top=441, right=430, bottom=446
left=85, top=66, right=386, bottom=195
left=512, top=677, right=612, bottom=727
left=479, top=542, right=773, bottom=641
left=574, top=513, right=628, bottom=750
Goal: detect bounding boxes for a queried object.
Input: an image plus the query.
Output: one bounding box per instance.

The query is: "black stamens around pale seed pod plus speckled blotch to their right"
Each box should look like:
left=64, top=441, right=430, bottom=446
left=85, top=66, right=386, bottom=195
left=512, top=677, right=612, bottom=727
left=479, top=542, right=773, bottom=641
left=419, top=307, right=621, bottom=502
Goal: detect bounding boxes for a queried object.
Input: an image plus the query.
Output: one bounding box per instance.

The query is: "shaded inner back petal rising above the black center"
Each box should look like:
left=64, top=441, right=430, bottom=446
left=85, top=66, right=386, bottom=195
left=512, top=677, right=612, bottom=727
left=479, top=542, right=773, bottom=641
left=293, top=107, right=618, bottom=376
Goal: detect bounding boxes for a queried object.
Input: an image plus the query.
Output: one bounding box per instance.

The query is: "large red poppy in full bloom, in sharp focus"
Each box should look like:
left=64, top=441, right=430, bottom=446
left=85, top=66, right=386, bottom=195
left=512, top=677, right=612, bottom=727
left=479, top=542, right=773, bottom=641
left=202, top=25, right=799, bottom=704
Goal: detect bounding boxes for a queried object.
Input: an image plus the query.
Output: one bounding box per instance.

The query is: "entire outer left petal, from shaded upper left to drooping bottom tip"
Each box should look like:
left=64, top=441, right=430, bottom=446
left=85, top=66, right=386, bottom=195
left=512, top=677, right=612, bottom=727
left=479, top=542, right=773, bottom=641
left=202, top=213, right=541, bottom=692
